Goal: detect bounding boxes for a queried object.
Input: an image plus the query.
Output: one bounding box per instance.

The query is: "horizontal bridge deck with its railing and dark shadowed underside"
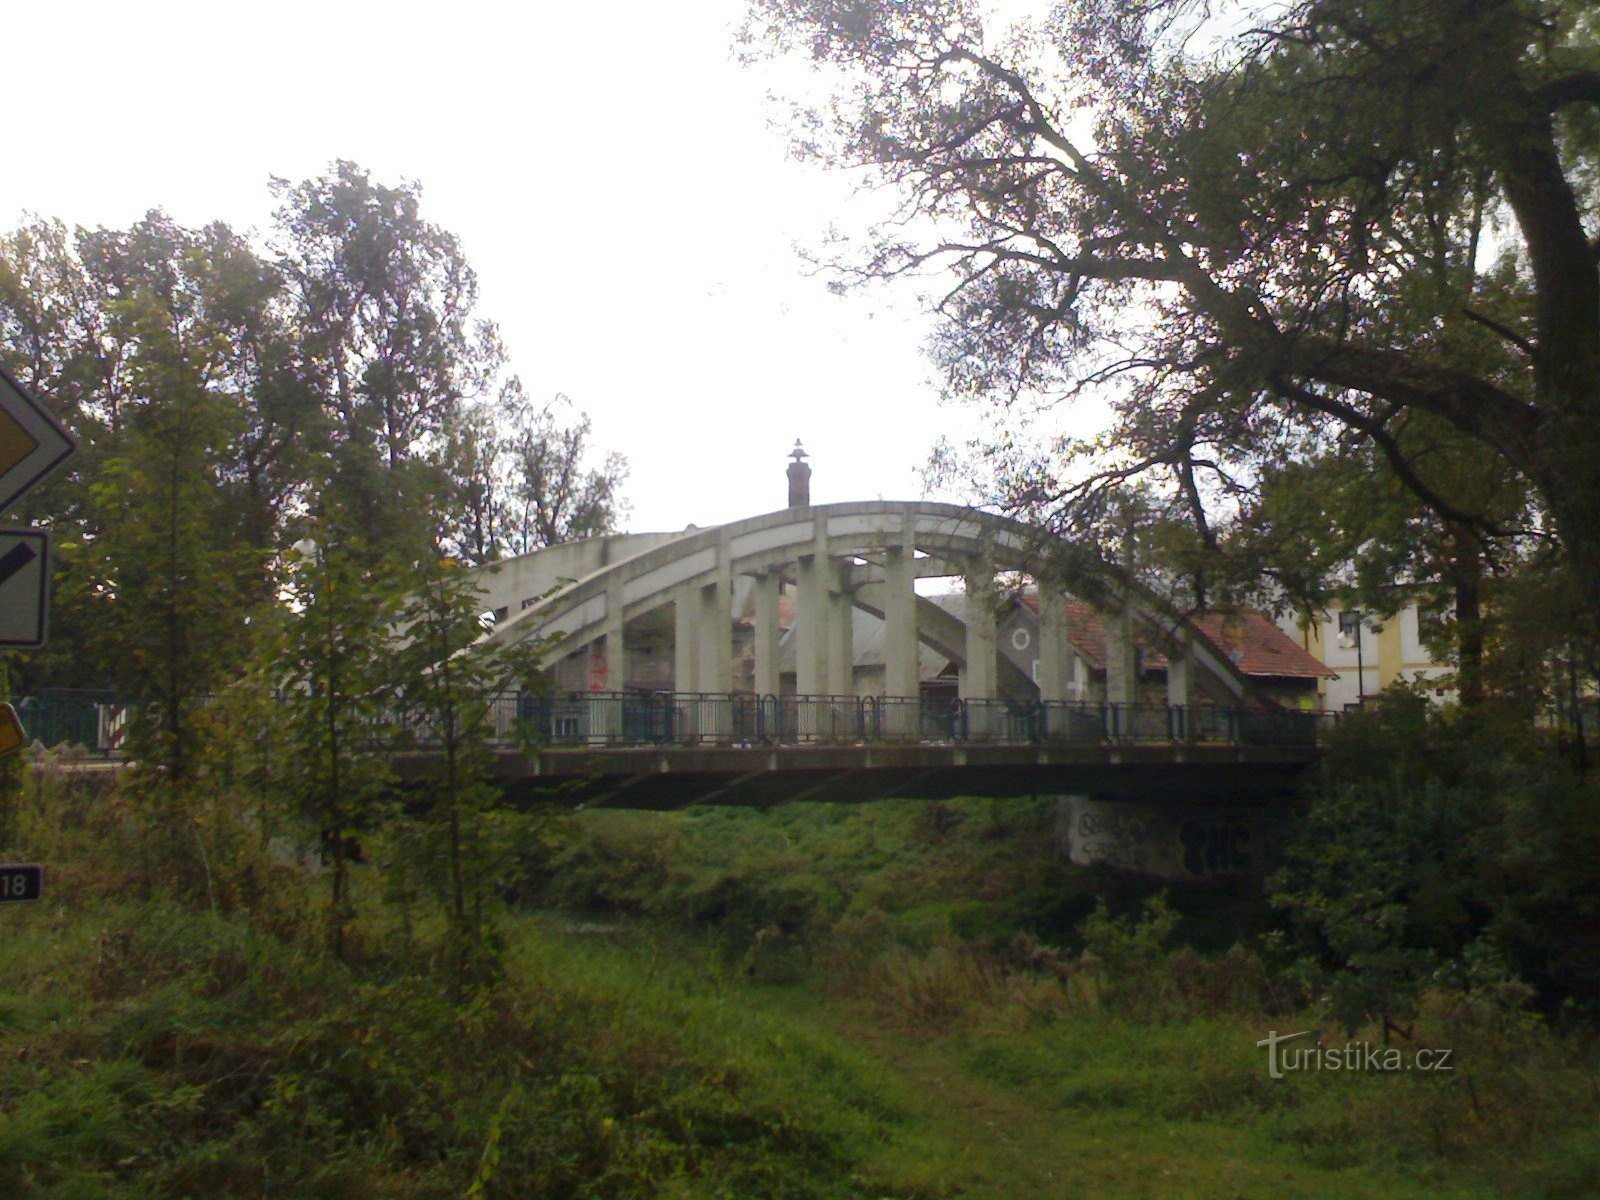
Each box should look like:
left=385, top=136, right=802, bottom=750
left=395, top=694, right=1325, bottom=808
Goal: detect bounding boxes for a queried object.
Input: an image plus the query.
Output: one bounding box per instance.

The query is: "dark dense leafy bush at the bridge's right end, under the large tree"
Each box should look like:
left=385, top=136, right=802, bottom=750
left=1272, top=693, right=1600, bottom=1027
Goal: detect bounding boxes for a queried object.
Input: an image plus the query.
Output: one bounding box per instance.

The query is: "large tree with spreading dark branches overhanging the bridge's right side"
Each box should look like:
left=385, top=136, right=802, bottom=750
left=747, top=0, right=1600, bottom=610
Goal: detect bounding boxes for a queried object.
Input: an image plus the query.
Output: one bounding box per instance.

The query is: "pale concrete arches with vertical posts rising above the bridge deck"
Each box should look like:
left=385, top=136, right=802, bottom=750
left=485, top=501, right=1250, bottom=704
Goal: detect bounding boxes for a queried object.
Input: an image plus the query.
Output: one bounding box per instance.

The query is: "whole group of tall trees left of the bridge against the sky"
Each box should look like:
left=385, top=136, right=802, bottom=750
left=0, top=162, right=626, bottom=704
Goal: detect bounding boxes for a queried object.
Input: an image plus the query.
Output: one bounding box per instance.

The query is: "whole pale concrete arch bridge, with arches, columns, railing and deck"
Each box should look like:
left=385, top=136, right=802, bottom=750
left=441, top=499, right=1317, bottom=803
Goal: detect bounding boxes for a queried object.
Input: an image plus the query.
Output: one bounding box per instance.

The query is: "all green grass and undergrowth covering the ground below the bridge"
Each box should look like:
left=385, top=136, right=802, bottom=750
left=0, top=704, right=1600, bottom=1200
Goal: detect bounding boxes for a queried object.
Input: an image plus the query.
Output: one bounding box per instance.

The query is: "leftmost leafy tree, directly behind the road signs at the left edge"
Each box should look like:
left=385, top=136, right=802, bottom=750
left=0, top=211, right=317, bottom=694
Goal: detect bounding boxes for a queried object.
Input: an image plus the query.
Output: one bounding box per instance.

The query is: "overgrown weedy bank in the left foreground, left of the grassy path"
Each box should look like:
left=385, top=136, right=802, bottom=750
left=0, top=782, right=928, bottom=1200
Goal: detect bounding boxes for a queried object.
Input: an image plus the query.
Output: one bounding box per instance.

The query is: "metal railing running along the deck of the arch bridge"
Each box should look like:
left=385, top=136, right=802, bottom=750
left=470, top=691, right=1333, bottom=747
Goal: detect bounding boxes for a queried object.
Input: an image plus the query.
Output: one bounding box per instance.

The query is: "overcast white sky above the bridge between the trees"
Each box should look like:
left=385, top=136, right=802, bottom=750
left=0, top=0, right=1075, bottom=530
